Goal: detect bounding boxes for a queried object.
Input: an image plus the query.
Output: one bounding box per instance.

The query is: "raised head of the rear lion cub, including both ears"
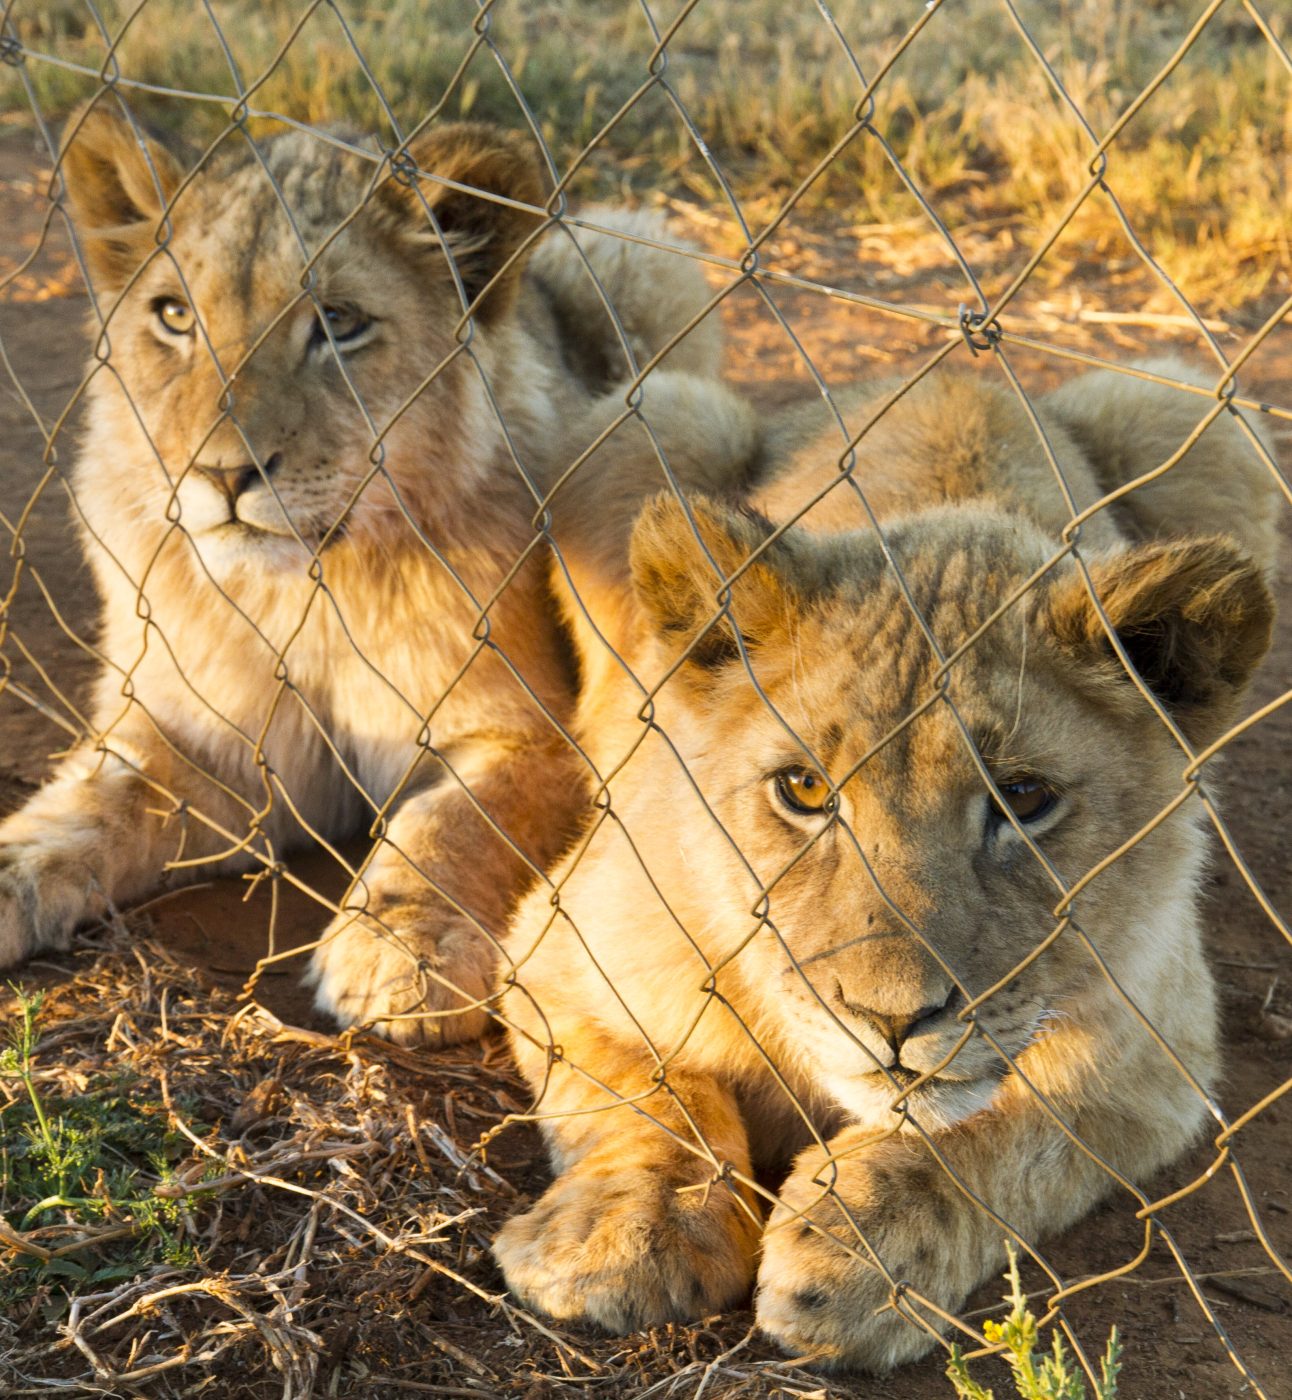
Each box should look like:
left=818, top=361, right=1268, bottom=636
left=63, top=109, right=539, bottom=578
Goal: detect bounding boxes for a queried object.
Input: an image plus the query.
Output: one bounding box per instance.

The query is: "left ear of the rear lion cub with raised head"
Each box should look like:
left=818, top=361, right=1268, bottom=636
left=60, top=106, right=183, bottom=291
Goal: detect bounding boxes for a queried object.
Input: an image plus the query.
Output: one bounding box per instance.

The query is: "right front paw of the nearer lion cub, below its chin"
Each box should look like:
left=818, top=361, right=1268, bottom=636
left=756, top=1149, right=973, bottom=1373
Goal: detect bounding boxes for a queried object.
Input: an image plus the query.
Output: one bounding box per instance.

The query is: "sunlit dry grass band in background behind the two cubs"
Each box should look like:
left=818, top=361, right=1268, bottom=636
left=0, top=0, right=1292, bottom=311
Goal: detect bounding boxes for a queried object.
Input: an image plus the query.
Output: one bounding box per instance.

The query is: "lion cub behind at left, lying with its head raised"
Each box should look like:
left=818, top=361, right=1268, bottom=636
left=0, top=98, right=743, bottom=1040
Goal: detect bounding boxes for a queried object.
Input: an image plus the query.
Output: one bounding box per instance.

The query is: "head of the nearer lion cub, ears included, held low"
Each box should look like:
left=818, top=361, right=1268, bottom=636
left=633, top=504, right=1271, bottom=1128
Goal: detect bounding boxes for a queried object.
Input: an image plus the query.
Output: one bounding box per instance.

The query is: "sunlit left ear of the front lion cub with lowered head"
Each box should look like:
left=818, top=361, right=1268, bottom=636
left=630, top=493, right=799, bottom=672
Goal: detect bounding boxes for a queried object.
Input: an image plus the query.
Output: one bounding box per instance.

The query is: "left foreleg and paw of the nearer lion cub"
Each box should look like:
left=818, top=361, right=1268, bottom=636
left=494, top=1052, right=761, bottom=1331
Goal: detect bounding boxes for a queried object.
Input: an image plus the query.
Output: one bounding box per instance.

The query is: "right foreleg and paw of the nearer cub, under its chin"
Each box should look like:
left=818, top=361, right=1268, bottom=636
left=756, top=1005, right=1212, bottom=1372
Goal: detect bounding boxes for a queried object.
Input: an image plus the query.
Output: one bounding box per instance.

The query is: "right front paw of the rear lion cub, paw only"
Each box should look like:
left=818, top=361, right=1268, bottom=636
left=309, top=914, right=494, bottom=1046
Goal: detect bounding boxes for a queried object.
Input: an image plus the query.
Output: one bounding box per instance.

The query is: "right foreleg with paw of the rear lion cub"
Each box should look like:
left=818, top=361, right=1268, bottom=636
left=309, top=735, right=585, bottom=1046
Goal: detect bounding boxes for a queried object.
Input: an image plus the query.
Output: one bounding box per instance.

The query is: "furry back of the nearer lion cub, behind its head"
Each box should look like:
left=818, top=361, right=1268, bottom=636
left=754, top=358, right=1281, bottom=573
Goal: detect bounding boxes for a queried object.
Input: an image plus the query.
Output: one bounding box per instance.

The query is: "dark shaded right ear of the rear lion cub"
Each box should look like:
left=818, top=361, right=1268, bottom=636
left=386, top=122, right=545, bottom=321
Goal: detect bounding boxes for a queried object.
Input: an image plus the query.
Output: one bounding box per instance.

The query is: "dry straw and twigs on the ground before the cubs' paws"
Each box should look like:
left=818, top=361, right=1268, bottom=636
left=0, top=924, right=852, bottom=1400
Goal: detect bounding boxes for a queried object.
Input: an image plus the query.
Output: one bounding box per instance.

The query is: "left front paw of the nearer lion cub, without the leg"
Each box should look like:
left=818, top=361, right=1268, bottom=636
left=494, top=1158, right=760, bottom=1333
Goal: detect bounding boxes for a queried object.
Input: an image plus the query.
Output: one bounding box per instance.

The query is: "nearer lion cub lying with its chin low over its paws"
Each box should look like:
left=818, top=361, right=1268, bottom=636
left=496, top=365, right=1275, bottom=1369
